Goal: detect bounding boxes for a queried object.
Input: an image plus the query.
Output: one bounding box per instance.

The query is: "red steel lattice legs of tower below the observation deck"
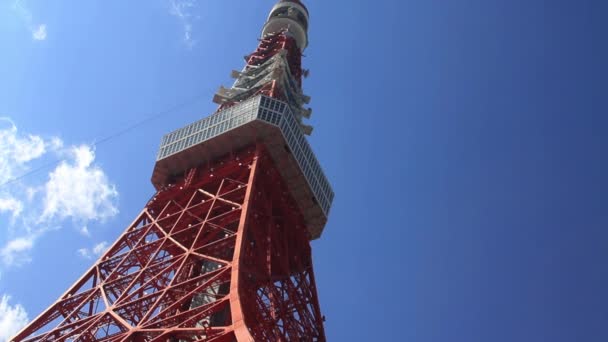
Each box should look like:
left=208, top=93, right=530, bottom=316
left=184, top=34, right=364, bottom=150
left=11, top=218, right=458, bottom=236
left=13, top=145, right=325, bottom=342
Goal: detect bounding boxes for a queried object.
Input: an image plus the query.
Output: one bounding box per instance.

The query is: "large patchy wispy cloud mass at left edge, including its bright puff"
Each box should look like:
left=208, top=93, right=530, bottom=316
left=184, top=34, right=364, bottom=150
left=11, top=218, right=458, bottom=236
left=0, top=117, right=118, bottom=269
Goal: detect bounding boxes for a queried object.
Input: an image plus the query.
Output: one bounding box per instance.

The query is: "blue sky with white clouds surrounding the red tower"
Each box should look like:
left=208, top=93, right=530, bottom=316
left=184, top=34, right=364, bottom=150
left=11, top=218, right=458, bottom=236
left=0, top=0, right=608, bottom=342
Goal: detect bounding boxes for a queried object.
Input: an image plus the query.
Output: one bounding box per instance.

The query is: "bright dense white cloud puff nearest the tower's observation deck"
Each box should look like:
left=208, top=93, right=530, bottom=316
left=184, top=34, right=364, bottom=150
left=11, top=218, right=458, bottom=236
left=41, top=145, right=118, bottom=221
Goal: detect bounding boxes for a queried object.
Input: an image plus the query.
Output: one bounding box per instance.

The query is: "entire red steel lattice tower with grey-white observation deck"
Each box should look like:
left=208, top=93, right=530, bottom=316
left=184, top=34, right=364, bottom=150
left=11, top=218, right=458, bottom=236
left=12, top=0, right=333, bottom=342
